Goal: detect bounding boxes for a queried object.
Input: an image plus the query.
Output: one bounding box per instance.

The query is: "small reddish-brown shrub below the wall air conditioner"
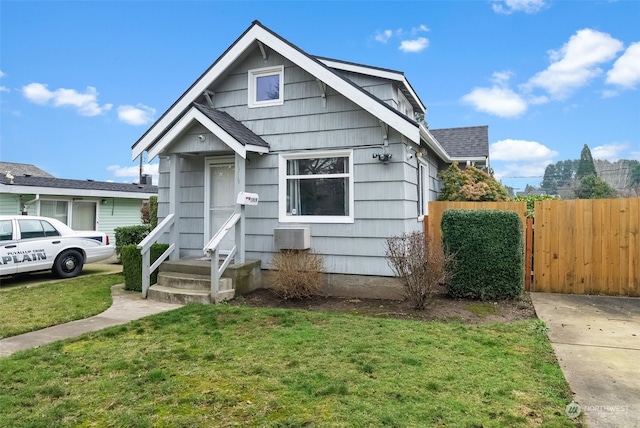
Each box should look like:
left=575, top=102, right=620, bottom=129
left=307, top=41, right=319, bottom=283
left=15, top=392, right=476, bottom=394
left=271, top=250, right=325, bottom=299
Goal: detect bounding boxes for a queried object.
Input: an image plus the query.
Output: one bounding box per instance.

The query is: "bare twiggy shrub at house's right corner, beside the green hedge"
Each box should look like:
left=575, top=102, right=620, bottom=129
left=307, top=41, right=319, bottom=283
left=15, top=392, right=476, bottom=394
left=385, top=232, right=453, bottom=309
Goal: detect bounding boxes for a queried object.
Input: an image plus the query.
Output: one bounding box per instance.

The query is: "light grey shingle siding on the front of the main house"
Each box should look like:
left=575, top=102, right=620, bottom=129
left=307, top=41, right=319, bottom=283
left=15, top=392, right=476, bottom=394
left=158, top=49, right=437, bottom=276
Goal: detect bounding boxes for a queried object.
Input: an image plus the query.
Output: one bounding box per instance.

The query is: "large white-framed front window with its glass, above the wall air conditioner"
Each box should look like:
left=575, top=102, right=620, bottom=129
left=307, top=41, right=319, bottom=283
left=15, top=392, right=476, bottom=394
left=280, top=151, right=353, bottom=223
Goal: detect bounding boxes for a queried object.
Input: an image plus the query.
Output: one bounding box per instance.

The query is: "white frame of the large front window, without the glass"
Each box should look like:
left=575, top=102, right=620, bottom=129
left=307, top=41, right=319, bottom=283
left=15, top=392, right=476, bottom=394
left=278, top=150, right=354, bottom=223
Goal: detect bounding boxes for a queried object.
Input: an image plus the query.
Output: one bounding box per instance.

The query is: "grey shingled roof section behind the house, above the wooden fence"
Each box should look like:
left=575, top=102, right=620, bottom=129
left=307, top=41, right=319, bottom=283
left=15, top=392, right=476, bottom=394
left=429, top=125, right=489, bottom=158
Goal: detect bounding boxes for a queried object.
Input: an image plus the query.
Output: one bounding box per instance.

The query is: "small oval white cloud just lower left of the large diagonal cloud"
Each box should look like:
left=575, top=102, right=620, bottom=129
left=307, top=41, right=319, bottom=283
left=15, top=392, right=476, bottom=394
left=462, top=86, right=527, bottom=117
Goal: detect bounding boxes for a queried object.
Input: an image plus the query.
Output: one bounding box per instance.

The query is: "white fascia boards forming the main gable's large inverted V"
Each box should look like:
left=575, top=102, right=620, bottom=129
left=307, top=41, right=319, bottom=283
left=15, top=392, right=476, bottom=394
left=132, top=25, right=420, bottom=160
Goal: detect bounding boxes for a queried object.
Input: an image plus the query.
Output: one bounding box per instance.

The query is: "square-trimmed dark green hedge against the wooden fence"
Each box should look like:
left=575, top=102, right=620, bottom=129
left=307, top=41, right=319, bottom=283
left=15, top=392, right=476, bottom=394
left=441, top=210, right=524, bottom=300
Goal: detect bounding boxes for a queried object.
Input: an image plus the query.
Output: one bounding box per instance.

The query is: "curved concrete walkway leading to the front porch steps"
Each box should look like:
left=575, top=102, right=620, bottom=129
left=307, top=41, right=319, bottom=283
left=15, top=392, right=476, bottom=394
left=0, top=284, right=182, bottom=357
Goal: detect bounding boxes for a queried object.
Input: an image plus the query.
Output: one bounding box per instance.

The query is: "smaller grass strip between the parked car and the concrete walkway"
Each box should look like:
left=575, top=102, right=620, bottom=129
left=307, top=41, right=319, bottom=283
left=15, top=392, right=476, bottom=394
left=0, top=274, right=124, bottom=339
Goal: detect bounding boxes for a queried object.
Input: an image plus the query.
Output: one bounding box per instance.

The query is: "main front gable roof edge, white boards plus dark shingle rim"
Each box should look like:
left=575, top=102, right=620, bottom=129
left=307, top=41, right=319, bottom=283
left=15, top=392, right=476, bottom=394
left=132, top=21, right=428, bottom=159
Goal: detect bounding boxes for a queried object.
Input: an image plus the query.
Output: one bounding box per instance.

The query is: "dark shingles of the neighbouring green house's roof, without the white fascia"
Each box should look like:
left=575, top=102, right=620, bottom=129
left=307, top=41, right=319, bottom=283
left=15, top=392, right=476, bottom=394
left=0, top=172, right=158, bottom=193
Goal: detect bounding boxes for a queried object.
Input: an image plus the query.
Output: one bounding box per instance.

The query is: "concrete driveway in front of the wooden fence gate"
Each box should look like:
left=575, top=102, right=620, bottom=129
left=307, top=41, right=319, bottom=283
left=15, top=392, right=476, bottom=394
left=531, top=293, right=640, bottom=428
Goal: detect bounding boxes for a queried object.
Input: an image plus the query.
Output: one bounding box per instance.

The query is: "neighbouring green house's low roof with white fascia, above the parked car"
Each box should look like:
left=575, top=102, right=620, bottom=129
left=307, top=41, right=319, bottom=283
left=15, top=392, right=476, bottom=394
left=0, top=173, right=158, bottom=199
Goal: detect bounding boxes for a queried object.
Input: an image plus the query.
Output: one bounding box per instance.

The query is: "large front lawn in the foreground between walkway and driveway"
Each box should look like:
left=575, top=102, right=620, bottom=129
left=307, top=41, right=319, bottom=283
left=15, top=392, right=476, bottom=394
left=0, top=304, right=581, bottom=427
